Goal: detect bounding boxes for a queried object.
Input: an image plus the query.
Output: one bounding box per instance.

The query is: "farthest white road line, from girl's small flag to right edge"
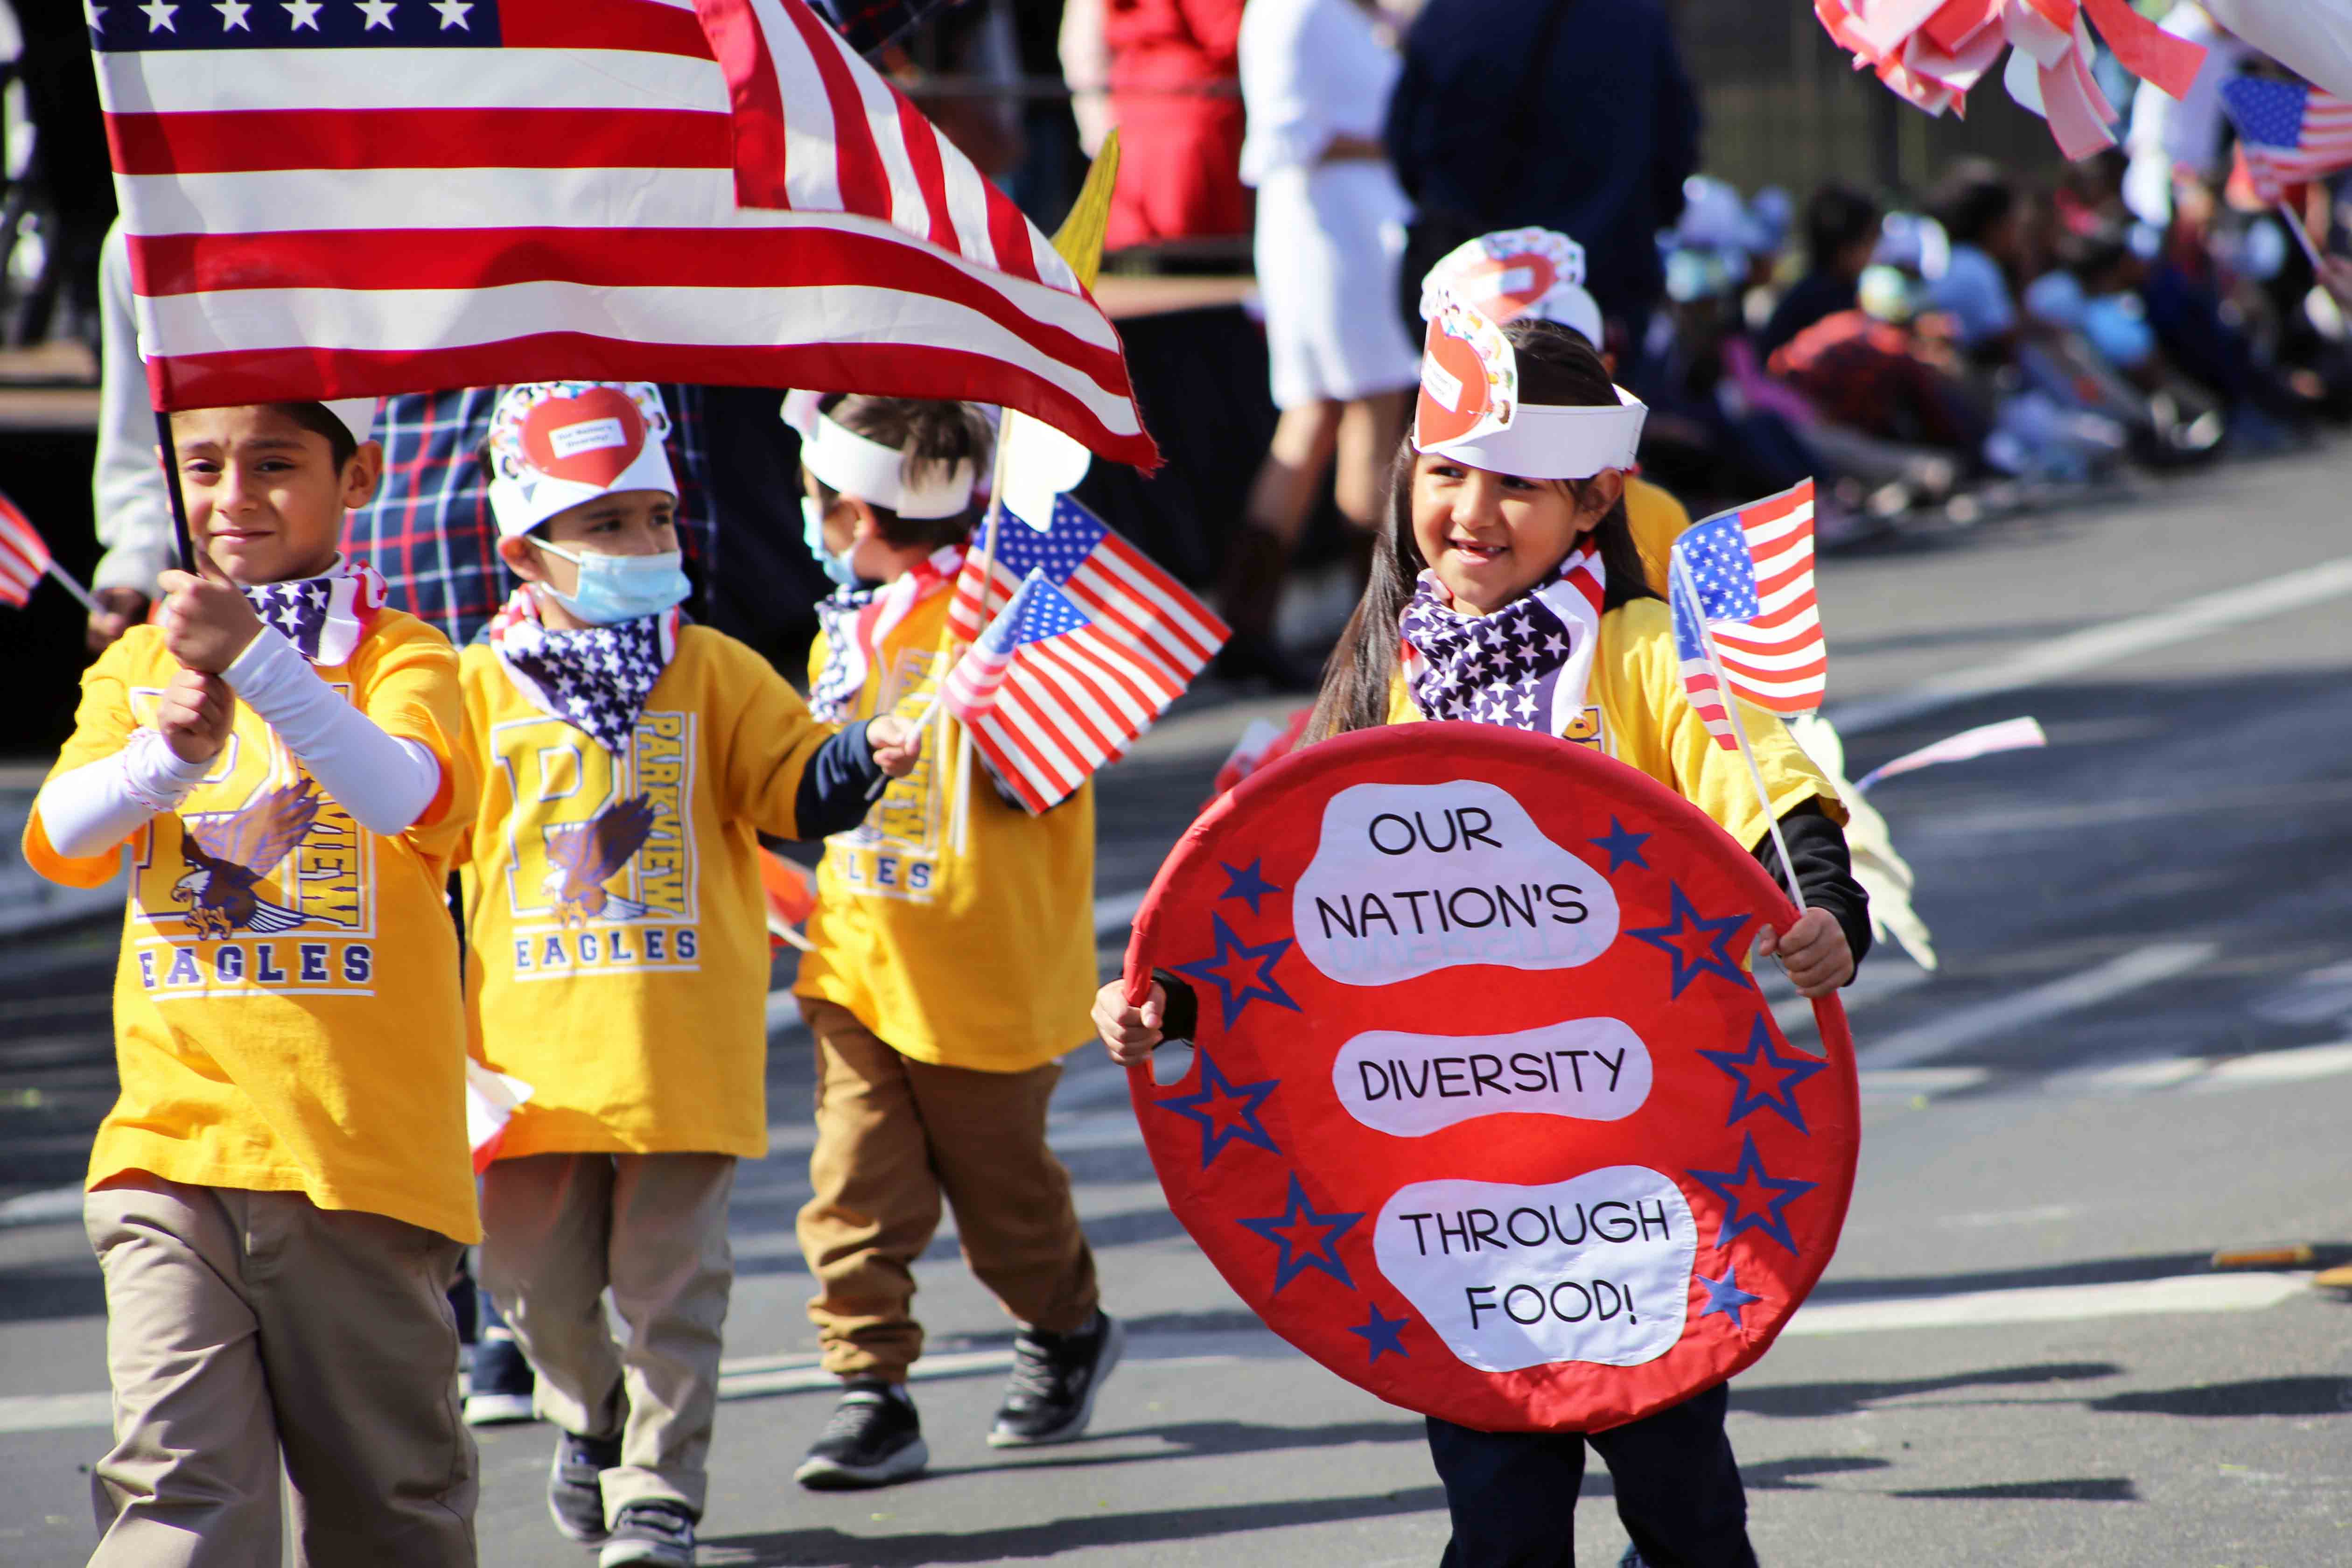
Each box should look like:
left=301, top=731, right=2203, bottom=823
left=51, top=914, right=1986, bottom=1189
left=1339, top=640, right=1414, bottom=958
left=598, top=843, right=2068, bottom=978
left=1830, top=555, right=2352, bottom=738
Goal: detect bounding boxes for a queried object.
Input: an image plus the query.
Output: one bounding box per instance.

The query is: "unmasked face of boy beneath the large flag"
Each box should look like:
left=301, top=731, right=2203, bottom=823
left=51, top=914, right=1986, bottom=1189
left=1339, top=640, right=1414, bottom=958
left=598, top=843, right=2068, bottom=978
left=172, top=404, right=384, bottom=583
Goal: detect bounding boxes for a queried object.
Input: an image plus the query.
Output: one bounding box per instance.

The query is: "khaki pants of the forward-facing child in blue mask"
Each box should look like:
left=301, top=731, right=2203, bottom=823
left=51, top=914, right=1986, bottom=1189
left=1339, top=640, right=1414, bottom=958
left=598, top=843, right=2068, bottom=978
left=482, top=1154, right=736, bottom=1523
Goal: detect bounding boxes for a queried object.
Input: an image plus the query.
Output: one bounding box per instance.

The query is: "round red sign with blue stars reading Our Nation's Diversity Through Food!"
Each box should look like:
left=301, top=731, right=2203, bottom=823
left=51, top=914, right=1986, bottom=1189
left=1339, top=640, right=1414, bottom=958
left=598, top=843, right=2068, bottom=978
left=1127, top=724, right=1861, bottom=1432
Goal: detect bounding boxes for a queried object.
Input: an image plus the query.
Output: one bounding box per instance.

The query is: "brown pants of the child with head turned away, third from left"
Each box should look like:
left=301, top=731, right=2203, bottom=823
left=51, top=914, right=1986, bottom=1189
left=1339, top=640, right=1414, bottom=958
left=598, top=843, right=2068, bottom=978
left=800, top=997, right=1099, bottom=1382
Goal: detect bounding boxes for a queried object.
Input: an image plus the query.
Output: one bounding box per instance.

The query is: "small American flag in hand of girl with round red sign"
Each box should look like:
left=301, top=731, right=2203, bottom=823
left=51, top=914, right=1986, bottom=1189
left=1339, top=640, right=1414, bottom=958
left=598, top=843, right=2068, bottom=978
left=1667, top=480, right=1830, bottom=750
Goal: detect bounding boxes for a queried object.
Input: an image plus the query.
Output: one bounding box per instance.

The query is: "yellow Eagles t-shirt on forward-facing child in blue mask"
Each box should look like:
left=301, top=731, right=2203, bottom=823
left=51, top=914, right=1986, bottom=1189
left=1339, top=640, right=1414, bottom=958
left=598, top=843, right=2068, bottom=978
left=461, top=625, right=835, bottom=1159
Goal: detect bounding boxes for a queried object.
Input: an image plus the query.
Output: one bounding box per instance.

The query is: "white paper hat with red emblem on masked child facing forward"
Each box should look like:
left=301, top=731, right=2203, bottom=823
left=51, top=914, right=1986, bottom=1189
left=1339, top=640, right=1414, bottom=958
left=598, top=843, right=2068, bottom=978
left=489, top=381, right=678, bottom=539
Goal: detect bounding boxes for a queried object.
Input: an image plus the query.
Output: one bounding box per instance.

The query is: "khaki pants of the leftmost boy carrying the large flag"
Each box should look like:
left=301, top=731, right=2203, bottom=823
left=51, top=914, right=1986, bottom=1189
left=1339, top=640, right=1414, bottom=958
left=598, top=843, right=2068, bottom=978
left=82, top=1176, right=475, bottom=1568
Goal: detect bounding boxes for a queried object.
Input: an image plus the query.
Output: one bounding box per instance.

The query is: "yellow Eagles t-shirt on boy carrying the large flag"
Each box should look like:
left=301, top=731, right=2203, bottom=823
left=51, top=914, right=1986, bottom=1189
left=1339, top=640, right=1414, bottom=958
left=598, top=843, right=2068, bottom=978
left=23, top=609, right=482, bottom=1241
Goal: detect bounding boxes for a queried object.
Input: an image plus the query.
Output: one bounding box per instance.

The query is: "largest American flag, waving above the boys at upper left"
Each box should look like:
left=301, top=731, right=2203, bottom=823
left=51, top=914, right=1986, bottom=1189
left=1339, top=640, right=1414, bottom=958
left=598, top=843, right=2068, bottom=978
left=84, top=0, right=1157, bottom=465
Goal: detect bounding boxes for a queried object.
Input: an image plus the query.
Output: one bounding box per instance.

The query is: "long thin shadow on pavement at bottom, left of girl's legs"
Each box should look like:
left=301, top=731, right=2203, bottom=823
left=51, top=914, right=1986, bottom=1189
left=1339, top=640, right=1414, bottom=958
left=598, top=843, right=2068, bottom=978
left=703, top=1486, right=1447, bottom=1568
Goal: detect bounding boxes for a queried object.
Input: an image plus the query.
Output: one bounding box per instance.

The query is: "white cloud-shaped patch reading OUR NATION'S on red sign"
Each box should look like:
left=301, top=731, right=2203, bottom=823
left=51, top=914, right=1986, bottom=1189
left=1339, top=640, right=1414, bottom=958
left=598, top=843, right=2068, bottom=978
left=1291, top=778, right=1618, bottom=985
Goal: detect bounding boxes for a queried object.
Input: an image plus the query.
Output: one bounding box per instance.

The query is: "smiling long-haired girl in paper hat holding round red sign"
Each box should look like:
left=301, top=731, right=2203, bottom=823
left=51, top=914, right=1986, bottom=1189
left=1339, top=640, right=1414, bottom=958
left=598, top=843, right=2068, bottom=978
left=1096, top=320, right=1870, bottom=1568
